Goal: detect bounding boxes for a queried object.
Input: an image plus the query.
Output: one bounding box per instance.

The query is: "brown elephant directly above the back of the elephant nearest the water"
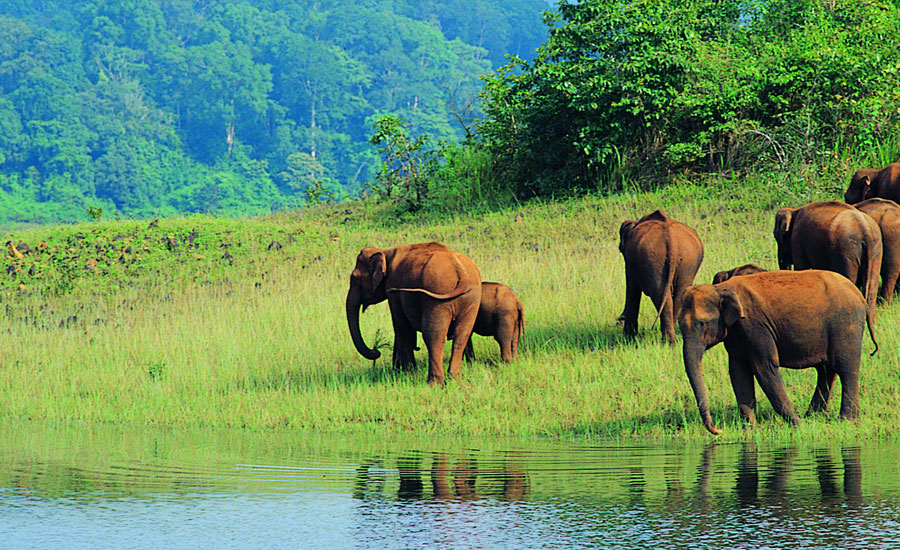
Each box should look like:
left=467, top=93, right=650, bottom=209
left=773, top=201, right=882, bottom=315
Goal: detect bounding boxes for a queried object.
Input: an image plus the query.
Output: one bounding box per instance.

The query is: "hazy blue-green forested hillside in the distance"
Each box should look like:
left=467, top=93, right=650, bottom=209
left=0, top=0, right=549, bottom=223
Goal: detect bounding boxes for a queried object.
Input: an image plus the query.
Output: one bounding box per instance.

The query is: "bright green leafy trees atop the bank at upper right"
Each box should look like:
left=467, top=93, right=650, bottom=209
left=480, top=0, right=900, bottom=196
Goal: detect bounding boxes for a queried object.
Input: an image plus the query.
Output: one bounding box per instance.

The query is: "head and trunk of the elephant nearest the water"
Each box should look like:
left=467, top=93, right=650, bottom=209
left=678, top=285, right=746, bottom=435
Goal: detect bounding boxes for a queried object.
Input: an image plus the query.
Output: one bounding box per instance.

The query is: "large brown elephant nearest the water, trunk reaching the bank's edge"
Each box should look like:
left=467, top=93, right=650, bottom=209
left=678, top=269, right=878, bottom=434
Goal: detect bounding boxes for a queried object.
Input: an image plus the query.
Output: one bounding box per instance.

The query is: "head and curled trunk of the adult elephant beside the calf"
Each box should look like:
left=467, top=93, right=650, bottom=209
left=346, top=248, right=387, bottom=361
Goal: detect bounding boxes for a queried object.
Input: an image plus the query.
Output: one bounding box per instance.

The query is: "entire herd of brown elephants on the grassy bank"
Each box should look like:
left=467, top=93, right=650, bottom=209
left=346, top=163, right=900, bottom=434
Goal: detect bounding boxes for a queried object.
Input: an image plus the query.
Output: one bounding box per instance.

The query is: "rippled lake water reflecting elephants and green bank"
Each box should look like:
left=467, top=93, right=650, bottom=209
left=0, top=423, right=900, bottom=549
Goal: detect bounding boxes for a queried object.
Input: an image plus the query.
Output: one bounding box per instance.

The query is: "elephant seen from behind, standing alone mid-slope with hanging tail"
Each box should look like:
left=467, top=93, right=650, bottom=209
left=619, top=210, right=703, bottom=344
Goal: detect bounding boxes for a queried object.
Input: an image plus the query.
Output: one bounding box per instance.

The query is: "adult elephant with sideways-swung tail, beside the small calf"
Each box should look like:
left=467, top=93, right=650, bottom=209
left=346, top=242, right=481, bottom=384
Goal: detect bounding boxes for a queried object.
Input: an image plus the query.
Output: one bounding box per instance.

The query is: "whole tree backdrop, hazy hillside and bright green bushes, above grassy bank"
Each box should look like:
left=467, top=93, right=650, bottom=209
left=0, top=0, right=900, bottom=224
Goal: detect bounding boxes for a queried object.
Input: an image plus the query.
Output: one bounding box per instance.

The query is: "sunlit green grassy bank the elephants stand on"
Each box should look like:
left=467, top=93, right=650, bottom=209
left=0, top=175, right=900, bottom=439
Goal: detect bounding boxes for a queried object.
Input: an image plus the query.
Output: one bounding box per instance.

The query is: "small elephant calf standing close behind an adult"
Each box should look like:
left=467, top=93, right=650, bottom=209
left=465, top=283, right=525, bottom=363
